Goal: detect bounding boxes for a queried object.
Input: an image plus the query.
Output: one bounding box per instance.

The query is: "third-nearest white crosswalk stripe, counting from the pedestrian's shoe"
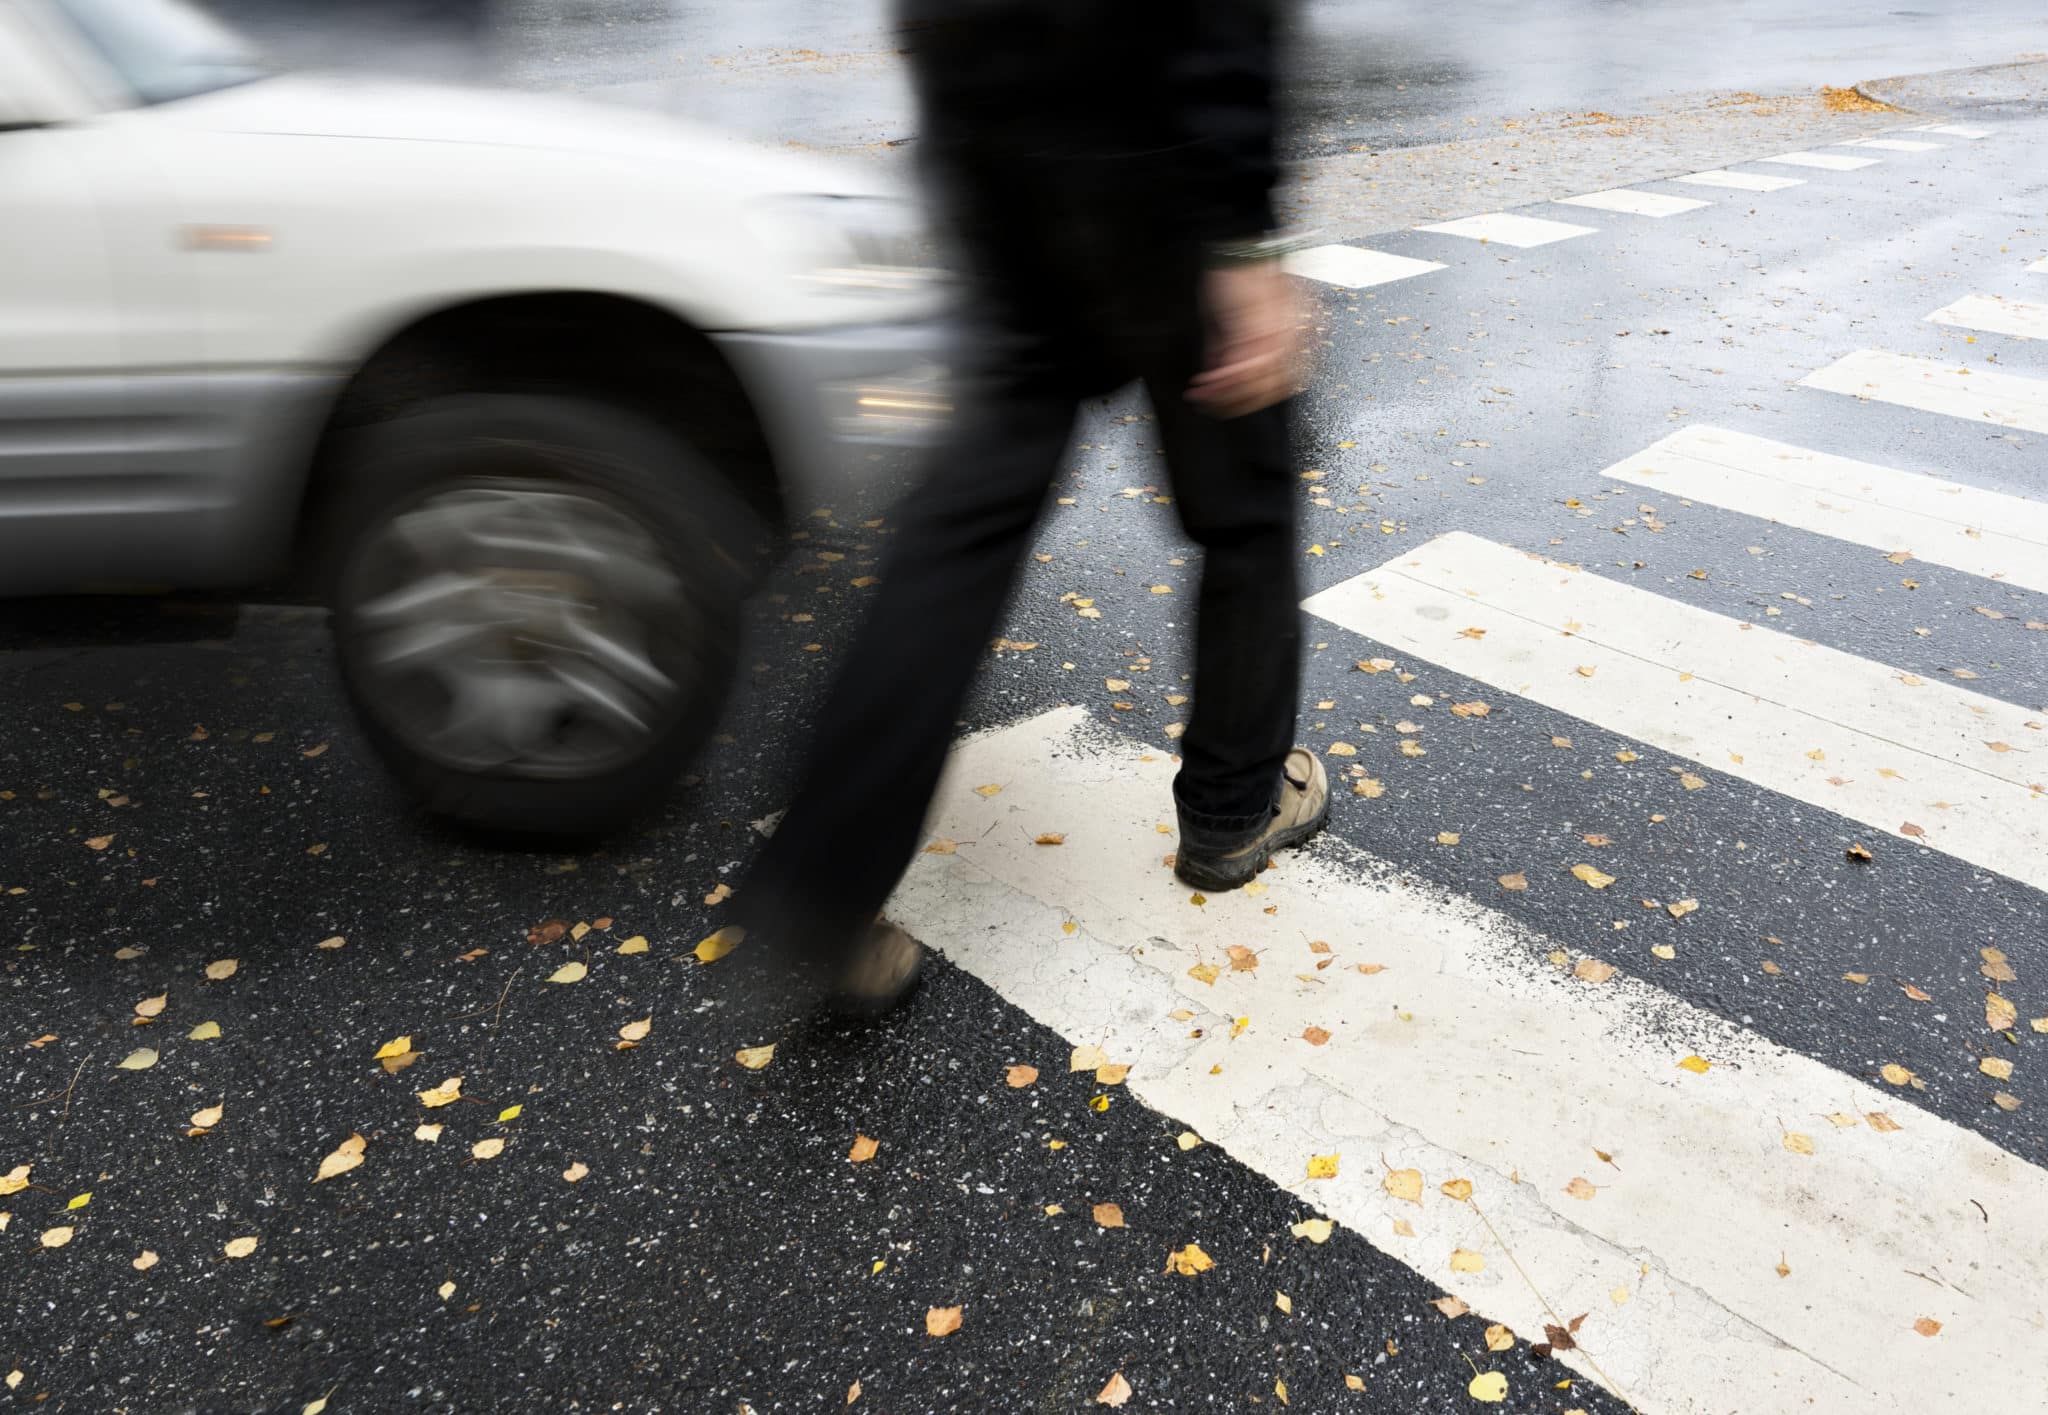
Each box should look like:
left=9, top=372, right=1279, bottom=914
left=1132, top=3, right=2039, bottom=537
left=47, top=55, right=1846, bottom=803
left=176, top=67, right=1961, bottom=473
left=1599, top=426, right=2048, bottom=597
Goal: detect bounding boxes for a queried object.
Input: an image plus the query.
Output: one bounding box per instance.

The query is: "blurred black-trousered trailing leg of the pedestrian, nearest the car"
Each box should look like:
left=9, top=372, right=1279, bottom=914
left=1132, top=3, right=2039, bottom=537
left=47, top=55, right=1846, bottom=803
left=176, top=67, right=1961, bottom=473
left=735, top=382, right=1073, bottom=960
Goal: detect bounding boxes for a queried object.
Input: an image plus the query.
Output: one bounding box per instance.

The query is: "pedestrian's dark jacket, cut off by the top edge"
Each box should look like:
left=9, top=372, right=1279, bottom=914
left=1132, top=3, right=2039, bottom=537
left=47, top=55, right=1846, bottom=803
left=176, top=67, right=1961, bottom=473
left=899, top=0, right=1286, bottom=242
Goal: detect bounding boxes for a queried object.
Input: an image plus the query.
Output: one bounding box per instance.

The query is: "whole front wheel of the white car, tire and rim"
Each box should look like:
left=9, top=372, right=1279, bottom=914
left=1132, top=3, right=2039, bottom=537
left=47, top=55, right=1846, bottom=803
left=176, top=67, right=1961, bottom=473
left=330, top=395, right=750, bottom=835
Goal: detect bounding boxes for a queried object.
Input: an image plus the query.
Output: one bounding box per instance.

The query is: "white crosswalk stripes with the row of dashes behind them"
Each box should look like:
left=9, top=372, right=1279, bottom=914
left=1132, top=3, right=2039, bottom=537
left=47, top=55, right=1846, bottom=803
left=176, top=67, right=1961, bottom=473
left=891, top=113, right=2048, bottom=1415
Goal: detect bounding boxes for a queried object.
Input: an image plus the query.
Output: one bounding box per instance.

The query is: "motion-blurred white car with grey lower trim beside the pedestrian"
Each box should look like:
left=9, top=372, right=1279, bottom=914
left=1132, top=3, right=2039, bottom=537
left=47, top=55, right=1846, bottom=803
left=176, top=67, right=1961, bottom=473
left=0, top=0, right=944, bottom=833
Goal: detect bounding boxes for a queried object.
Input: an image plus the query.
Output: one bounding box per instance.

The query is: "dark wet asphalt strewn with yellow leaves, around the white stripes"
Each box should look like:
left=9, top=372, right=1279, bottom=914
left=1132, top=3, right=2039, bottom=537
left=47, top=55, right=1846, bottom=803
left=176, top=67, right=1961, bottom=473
left=0, top=16, right=2048, bottom=1415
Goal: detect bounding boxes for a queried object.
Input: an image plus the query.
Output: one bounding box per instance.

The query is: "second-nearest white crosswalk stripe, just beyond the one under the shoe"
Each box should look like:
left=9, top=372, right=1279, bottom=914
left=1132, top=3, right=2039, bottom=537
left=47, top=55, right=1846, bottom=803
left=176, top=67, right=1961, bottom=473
left=1303, top=532, right=2048, bottom=889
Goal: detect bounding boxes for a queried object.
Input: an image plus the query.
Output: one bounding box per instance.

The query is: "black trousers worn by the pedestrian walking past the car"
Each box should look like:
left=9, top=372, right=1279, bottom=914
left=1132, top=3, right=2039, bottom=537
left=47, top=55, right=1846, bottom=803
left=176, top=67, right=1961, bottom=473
left=735, top=184, right=1300, bottom=956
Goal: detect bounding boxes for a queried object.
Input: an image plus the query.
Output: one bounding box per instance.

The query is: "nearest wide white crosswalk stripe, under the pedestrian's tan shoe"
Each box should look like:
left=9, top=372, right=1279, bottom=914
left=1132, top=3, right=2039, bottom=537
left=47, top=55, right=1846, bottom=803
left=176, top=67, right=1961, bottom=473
left=889, top=709, right=2048, bottom=1415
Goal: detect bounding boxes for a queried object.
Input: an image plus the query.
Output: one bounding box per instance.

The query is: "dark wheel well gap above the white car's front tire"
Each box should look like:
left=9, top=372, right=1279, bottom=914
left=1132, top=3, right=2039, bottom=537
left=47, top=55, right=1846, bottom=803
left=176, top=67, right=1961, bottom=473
left=295, top=293, right=784, bottom=577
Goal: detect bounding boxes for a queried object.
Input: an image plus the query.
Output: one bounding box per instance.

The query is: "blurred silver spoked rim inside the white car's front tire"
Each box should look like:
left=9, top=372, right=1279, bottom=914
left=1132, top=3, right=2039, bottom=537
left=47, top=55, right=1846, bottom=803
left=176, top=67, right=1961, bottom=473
left=340, top=479, right=702, bottom=778
